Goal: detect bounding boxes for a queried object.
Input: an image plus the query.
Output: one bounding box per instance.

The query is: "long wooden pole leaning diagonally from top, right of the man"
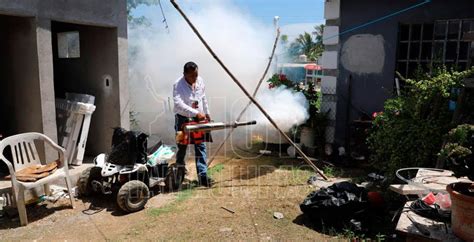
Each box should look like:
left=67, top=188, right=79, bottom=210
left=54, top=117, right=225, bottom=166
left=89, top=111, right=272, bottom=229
left=170, top=0, right=328, bottom=180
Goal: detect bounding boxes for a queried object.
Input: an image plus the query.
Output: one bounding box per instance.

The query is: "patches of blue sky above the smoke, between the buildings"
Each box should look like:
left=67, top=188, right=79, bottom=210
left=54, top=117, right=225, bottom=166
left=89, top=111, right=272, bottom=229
left=133, top=0, right=325, bottom=40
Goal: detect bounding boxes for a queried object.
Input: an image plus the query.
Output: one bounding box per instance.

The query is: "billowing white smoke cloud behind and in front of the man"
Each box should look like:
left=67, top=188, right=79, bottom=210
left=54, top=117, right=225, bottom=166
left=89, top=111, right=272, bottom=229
left=129, top=1, right=309, bottom=146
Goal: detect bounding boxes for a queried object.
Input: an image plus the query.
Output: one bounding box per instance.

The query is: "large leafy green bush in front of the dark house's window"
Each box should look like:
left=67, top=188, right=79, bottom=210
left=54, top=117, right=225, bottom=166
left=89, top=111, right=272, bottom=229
left=367, top=68, right=474, bottom=181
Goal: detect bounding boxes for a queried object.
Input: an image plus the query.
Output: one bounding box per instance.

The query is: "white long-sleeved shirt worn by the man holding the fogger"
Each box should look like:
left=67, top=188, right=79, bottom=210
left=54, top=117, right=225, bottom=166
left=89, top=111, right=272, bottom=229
left=173, top=76, right=209, bottom=118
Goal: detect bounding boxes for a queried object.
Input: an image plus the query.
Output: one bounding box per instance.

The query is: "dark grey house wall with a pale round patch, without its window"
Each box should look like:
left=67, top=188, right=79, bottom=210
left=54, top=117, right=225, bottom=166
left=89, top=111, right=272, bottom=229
left=336, top=0, right=474, bottom=144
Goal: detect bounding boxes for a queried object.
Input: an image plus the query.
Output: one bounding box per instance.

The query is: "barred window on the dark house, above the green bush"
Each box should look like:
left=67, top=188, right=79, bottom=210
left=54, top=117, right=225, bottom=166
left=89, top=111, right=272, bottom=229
left=396, top=19, right=474, bottom=77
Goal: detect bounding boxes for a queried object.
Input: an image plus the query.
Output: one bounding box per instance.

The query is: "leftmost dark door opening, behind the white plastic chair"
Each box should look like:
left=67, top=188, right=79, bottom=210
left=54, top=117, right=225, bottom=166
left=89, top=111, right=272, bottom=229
left=0, top=15, right=43, bottom=177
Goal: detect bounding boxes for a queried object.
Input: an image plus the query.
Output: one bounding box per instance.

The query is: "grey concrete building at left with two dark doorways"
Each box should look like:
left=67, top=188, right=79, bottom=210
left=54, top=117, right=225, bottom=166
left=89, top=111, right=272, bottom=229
left=0, top=0, right=129, bottom=159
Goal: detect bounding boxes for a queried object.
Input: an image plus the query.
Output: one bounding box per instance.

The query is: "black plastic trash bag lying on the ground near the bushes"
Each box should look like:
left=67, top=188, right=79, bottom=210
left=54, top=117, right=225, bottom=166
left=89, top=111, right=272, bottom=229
left=300, top=182, right=368, bottom=230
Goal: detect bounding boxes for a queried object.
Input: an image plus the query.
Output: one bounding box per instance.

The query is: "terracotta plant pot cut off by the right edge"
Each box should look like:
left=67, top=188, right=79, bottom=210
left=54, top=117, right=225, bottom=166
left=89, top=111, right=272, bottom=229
left=446, top=182, right=474, bottom=241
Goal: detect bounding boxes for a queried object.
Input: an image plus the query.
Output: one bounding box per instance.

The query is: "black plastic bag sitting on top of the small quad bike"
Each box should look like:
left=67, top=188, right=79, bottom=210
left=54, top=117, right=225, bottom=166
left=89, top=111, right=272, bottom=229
left=108, top=128, right=148, bottom=165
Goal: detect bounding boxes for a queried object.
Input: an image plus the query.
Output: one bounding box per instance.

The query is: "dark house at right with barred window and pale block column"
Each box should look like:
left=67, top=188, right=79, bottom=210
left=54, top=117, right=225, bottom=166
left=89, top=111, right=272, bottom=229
left=321, top=0, right=474, bottom=145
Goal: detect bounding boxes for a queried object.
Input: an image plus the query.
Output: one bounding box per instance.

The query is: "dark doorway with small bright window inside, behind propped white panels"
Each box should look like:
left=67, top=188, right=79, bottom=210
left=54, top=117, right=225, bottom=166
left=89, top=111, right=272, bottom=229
left=51, top=21, right=120, bottom=155
